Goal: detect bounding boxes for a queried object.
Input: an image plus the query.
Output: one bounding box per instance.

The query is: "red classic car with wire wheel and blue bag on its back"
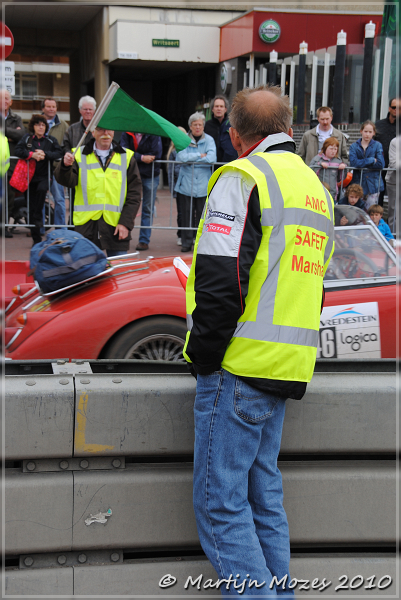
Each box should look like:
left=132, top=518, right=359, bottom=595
left=5, top=207, right=399, bottom=361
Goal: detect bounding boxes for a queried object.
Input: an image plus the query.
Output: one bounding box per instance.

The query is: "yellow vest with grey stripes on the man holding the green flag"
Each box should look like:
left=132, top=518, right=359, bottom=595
left=73, top=148, right=134, bottom=227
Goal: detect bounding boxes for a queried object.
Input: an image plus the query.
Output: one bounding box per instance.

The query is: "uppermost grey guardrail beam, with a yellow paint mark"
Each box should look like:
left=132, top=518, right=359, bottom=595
left=5, top=372, right=396, bottom=460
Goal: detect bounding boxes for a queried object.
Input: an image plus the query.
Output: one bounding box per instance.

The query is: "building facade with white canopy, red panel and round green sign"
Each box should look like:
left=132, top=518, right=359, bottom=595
left=2, top=0, right=383, bottom=127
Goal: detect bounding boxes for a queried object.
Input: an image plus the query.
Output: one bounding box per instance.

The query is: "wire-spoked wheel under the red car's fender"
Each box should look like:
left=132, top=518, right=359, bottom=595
left=104, top=317, right=187, bottom=362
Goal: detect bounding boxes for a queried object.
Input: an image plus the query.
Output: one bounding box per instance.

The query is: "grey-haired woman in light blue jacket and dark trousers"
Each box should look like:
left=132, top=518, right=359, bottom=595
left=174, top=112, right=216, bottom=252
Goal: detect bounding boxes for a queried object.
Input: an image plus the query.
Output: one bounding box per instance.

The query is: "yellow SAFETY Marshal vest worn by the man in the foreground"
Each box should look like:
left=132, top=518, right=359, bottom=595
left=184, top=152, right=334, bottom=382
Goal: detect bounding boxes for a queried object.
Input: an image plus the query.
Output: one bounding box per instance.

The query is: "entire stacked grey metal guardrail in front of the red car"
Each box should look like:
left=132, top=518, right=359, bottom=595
left=4, top=360, right=399, bottom=598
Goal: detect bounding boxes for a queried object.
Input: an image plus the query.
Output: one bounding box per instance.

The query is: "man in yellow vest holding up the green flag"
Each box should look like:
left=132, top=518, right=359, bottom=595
left=55, top=127, right=142, bottom=256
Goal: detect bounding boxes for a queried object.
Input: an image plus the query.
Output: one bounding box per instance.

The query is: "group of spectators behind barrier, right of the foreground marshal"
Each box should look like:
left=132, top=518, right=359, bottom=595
left=298, top=98, right=401, bottom=240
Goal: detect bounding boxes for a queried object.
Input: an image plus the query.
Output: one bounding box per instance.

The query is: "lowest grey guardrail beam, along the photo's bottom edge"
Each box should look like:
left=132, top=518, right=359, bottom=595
left=5, top=551, right=399, bottom=600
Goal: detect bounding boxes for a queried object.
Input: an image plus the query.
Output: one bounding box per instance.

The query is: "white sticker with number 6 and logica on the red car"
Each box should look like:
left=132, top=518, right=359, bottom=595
left=317, top=302, right=381, bottom=358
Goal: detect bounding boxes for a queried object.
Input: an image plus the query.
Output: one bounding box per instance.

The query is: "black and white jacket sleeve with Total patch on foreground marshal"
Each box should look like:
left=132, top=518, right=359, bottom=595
left=186, top=180, right=262, bottom=375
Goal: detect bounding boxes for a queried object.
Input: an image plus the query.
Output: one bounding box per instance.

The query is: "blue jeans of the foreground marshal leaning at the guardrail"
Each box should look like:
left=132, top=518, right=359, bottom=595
left=194, top=369, right=294, bottom=597
